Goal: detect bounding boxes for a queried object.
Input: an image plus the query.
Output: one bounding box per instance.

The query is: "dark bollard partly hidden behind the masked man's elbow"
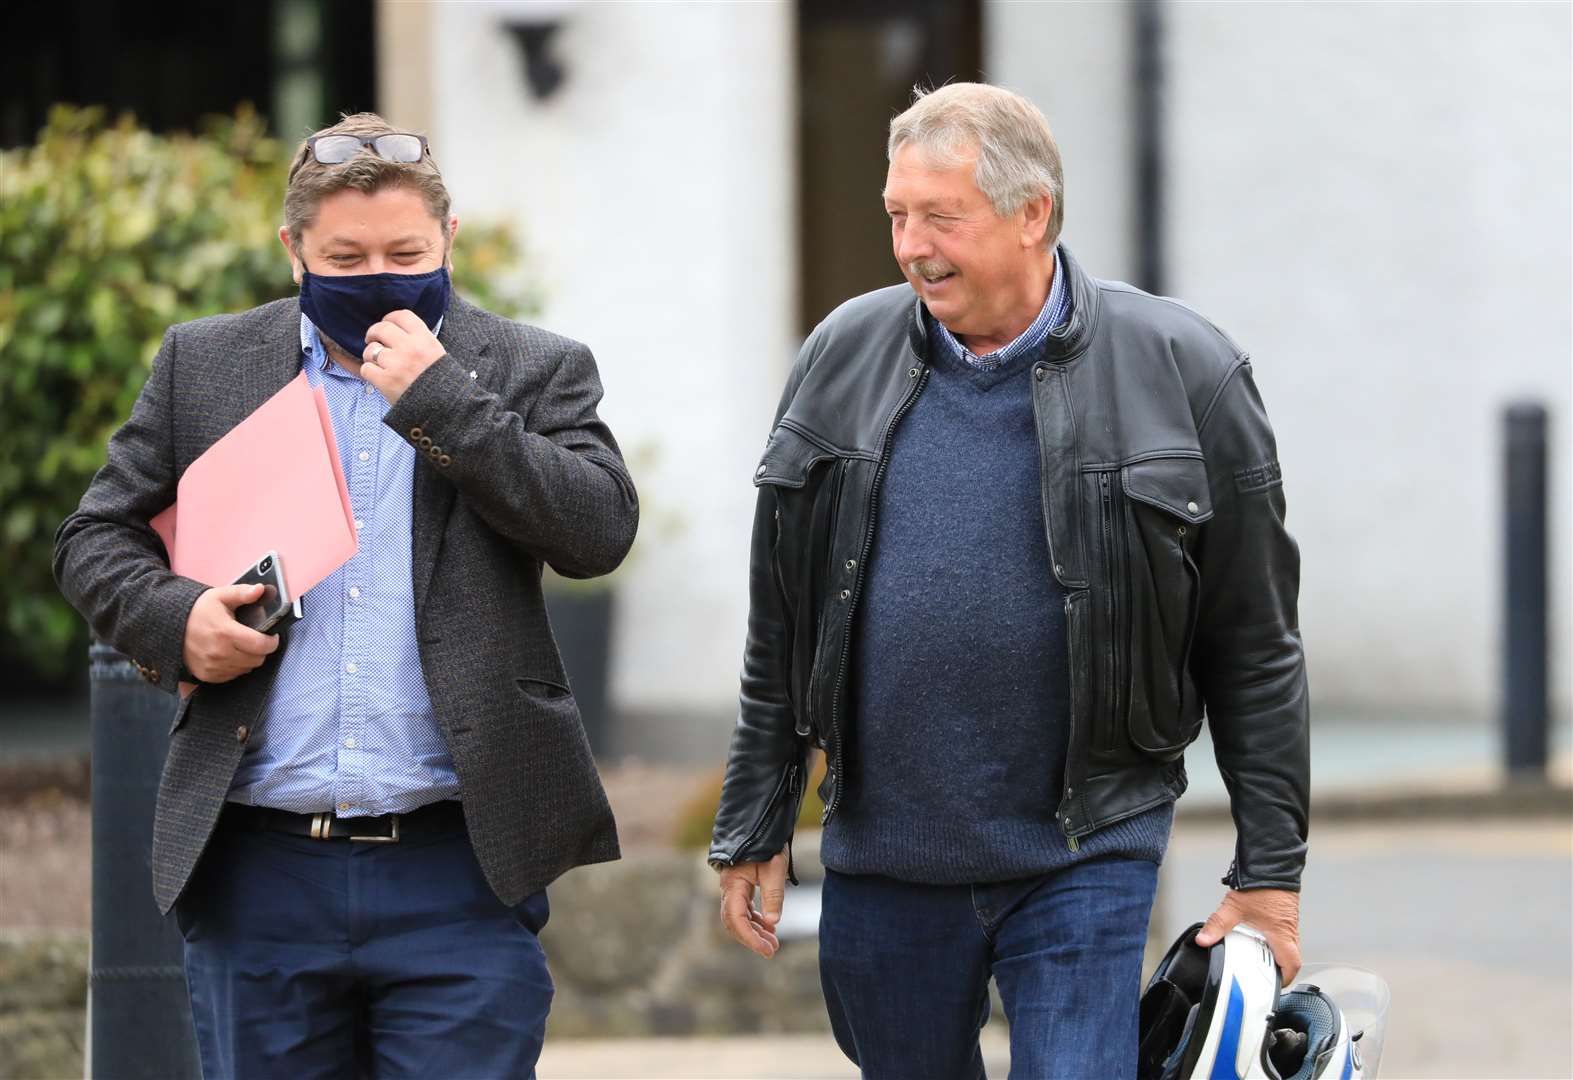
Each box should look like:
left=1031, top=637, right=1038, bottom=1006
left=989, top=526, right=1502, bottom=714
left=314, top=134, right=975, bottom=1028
left=87, top=645, right=201, bottom=1080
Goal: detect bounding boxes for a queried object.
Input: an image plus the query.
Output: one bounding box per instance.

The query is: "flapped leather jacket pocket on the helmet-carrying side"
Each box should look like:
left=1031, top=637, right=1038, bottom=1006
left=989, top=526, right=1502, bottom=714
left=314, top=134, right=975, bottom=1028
left=1100, top=457, right=1213, bottom=761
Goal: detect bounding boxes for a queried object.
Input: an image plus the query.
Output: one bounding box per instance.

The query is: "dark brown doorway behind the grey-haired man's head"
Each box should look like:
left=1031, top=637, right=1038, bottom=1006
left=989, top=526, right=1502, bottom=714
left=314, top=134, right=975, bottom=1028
left=798, top=0, right=983, bottom=333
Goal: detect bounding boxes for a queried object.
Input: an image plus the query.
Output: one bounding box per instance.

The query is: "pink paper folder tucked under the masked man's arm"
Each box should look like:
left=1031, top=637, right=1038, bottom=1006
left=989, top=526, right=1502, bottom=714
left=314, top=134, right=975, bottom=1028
left=149, top=373, right=359, bottom=599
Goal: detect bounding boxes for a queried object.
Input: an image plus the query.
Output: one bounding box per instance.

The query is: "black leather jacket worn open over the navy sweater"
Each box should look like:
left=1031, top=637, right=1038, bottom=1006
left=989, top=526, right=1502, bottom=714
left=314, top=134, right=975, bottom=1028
left=709, top=248, right=1309, bottom=890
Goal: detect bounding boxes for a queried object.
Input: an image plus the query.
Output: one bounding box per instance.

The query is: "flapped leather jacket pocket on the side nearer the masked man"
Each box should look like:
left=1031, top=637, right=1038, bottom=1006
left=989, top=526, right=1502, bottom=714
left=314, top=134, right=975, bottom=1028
left=753, top=426, right=846, bottom=734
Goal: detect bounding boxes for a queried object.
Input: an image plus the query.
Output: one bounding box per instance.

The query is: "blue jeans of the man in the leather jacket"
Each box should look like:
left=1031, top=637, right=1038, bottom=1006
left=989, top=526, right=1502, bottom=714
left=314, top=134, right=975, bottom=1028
left=820, top=857, right=1158, bottom=1080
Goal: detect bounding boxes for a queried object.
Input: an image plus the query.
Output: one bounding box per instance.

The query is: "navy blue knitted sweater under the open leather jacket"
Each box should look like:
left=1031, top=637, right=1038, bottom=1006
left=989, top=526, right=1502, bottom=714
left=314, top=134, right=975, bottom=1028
left=821, top=319, right=1173, bottom=885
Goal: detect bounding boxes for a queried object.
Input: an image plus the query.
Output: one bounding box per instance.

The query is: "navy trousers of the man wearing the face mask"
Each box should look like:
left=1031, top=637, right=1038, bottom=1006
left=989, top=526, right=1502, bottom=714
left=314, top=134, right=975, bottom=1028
left=175, top=825, right=552, bottom=1080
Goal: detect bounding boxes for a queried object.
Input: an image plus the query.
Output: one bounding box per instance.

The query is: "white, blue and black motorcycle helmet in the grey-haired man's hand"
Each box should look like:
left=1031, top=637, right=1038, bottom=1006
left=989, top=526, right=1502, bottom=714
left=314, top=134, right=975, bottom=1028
left=1137, top=923, right=1386, bottom=1080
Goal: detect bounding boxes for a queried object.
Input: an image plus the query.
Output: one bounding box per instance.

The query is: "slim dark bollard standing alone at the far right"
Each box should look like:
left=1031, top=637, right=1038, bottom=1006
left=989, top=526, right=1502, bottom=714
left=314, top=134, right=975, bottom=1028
left=1502, top=402, right=1549, bottom=780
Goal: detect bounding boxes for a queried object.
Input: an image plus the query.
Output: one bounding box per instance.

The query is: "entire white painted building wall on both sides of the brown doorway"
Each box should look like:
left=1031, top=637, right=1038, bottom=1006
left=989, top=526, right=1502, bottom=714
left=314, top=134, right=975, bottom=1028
left=402, top=2, right=1573, bottom=726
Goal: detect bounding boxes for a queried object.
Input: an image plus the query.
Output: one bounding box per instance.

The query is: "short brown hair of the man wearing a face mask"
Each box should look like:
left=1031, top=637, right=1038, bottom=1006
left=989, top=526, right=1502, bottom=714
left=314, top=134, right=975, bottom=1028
left=285, top=113, right=453, bottom=252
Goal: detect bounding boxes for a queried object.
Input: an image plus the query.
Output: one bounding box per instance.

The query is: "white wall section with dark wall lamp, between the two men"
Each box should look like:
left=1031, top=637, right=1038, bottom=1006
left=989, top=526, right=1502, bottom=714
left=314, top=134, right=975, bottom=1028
left=424, top=3, right=798, bottom=714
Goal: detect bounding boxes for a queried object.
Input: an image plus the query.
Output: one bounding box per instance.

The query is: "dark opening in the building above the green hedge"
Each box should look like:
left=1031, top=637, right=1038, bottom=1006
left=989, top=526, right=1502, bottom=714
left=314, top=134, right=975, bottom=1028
left=0, top=0, right=376, bottom=148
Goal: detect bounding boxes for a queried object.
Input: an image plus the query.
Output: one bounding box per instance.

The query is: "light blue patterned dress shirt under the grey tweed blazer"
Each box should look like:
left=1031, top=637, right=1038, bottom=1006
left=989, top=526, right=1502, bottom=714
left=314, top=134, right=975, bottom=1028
left=230, top=316, right=459, bottom=817
